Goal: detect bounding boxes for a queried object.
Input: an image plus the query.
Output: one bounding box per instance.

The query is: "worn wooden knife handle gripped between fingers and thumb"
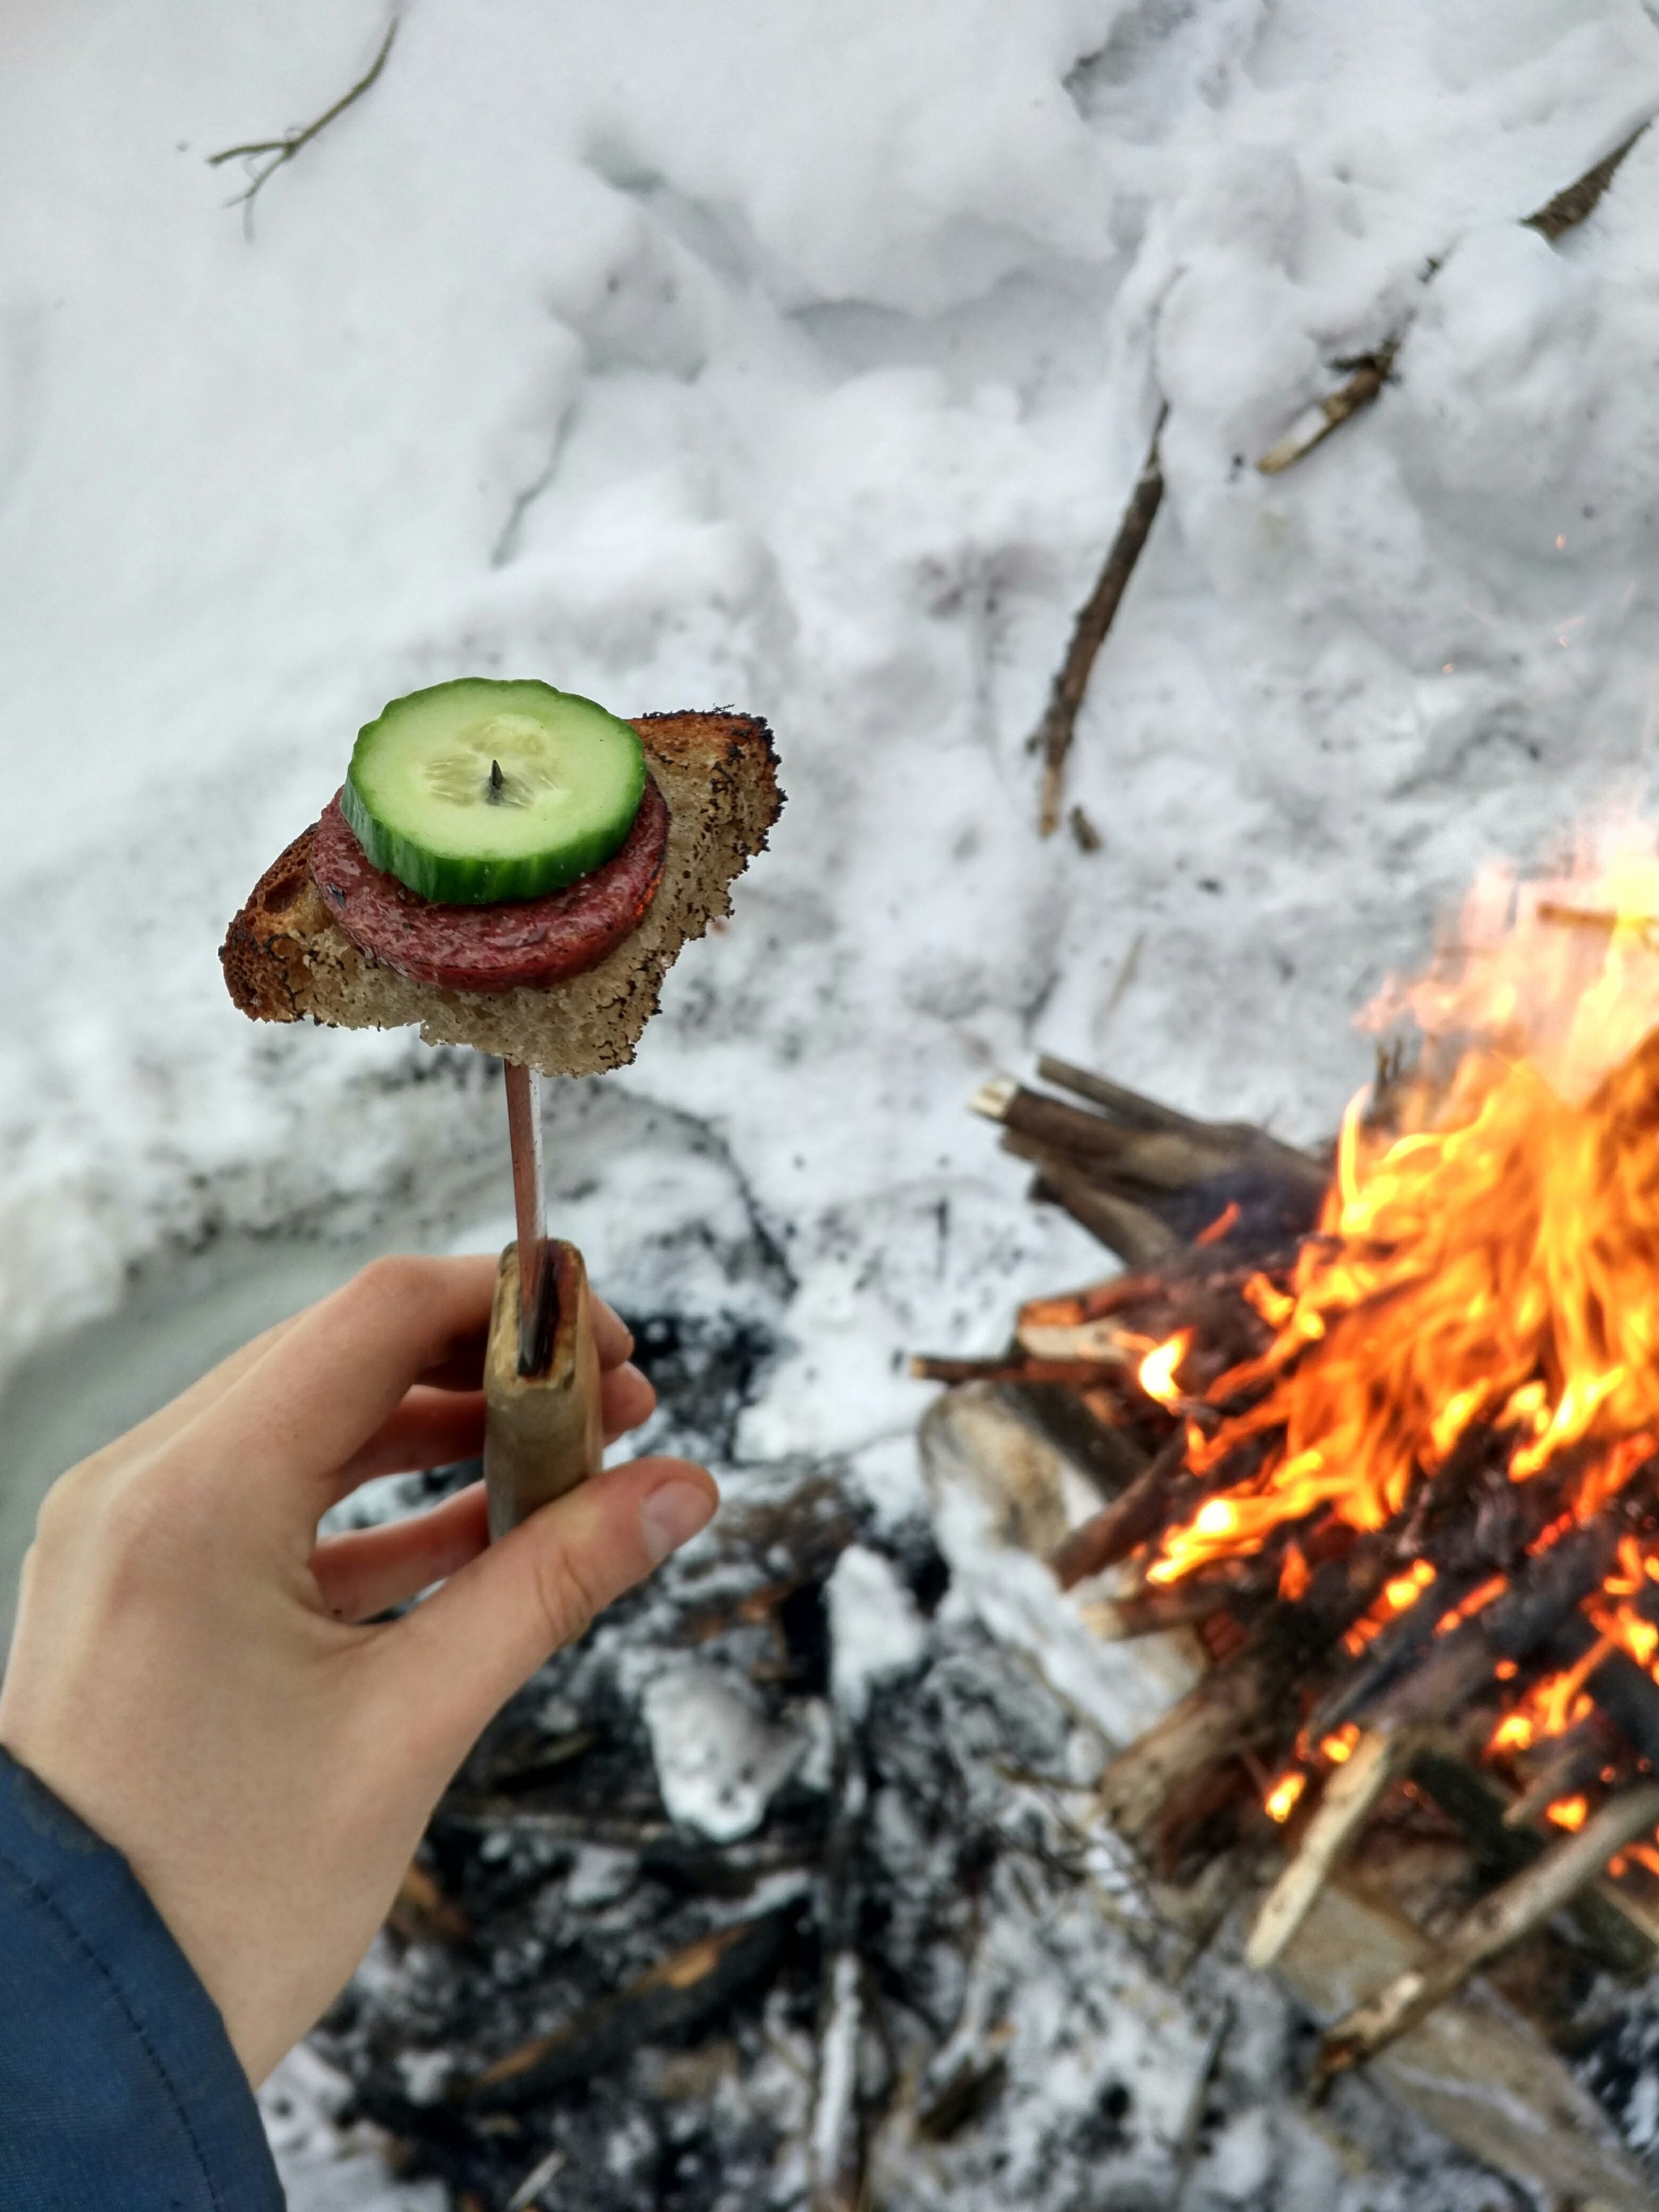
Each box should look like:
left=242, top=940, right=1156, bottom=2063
left=484, top=1243, right=603, bottom=1539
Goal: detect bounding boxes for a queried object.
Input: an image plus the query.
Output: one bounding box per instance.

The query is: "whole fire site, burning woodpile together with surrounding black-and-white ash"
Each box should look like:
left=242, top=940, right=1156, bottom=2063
left=292, top=831, right=1659, bottom=2212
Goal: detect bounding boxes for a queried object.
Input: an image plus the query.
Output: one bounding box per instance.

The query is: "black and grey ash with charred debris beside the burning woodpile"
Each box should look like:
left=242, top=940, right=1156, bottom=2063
left=267, top=1323, right=1508, bottom=2212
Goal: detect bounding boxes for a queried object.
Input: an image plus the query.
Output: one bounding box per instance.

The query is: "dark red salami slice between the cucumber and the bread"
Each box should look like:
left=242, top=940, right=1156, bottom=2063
left=312, top=776, right=668, bottom=991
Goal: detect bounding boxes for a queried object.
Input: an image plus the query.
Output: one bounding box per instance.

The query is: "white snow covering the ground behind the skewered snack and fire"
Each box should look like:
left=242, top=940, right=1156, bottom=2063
left=0, top=0, right=1659, bottom=2203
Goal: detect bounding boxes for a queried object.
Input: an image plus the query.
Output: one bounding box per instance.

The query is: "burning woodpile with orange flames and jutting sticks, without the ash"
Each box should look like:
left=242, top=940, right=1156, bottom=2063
left=915, top=825, right=1659, bottom=2077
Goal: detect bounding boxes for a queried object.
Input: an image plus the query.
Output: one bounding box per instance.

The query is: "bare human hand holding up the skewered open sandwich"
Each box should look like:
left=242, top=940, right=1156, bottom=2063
left=0, top=1258, right=719, bottom=2084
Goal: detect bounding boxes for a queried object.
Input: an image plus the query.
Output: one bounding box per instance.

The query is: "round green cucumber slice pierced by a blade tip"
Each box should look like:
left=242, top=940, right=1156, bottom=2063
left=341, top=677, right=646, bottom=907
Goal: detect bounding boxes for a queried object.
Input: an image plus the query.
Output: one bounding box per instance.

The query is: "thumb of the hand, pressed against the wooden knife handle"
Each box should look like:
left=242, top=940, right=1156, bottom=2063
left=382, top=1458, right=719, bottom=1767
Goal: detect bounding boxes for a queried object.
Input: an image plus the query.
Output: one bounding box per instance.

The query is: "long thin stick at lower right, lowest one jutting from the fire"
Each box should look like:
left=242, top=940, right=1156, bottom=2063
left=1314, top=1783, right=1659, bottom=2079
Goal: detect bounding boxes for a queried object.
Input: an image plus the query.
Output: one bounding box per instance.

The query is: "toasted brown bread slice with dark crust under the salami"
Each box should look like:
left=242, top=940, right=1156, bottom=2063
left=219, top=712, right=783, bottom=1075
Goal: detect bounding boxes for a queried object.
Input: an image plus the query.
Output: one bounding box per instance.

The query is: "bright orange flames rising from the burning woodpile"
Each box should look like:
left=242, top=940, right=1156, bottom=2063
left=1141, top=825, right=1659, bottom=1592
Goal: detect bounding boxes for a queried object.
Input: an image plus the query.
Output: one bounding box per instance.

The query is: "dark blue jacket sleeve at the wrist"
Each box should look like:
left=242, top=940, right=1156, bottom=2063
left=0, top=1749, right=284, bottom=2212
